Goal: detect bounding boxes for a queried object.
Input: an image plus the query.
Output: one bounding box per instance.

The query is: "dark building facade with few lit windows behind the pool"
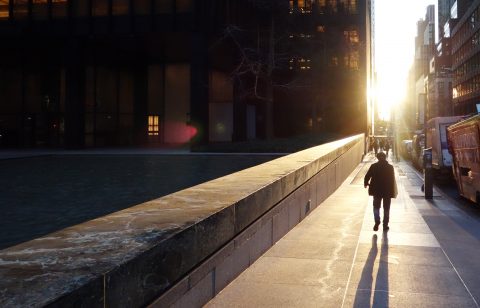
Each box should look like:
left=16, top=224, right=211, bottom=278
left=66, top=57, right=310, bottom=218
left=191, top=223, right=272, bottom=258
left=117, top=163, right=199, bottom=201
left=0, top=0, right=370, bottom=148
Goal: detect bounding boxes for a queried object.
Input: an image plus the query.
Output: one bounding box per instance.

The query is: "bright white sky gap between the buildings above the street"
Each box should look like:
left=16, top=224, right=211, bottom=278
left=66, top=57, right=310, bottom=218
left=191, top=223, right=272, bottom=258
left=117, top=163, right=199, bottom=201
left=375, top=0, right=436, bottom=117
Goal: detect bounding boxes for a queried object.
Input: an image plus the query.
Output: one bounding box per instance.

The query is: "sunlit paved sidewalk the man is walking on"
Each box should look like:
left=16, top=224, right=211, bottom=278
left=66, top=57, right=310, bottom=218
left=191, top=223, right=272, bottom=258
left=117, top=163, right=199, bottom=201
left=207, top=155, right=480, bottom=307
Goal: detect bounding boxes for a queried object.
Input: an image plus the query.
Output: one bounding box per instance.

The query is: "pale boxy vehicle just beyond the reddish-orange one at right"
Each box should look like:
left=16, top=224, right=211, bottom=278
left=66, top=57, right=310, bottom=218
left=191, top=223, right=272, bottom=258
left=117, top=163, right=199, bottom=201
left=427, top=116, right=465, bottom=173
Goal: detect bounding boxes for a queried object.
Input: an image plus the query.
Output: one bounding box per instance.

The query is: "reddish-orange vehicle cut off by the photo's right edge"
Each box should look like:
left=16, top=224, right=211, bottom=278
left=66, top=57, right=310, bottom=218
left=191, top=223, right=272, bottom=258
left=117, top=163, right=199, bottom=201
left=447, top=115, right=480, bottom=204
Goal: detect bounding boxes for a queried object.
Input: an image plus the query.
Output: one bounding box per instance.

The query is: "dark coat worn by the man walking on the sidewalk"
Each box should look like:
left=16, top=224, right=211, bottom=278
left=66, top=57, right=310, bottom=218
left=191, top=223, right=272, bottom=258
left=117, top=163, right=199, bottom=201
left=363, top=160, right=397, bottom=198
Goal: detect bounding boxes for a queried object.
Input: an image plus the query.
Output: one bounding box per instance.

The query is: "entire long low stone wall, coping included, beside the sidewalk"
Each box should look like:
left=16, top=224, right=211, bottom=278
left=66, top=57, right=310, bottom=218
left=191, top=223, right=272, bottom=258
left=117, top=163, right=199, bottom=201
left=0, top=135, right=364, bottom=307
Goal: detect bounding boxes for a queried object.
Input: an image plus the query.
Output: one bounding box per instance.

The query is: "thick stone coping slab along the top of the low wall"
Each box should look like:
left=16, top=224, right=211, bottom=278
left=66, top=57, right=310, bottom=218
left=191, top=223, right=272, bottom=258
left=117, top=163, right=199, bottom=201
left=0, top=135, right=364, bottom=307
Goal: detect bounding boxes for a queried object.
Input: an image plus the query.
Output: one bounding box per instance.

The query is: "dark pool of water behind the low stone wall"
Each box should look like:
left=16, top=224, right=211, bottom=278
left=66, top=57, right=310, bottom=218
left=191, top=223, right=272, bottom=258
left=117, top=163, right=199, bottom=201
left=0, top=154, right=279, bottom=249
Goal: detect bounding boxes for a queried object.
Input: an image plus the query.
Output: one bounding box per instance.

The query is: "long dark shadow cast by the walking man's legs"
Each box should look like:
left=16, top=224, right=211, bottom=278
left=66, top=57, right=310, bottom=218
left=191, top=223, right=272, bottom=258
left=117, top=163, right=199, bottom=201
left=353, top=232, right=389, bottom=308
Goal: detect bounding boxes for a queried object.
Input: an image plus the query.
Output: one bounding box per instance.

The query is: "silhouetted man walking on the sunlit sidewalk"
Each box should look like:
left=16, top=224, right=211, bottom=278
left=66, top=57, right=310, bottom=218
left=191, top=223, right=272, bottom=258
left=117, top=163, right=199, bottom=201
left=363, top=152, right=397, bottom=231
